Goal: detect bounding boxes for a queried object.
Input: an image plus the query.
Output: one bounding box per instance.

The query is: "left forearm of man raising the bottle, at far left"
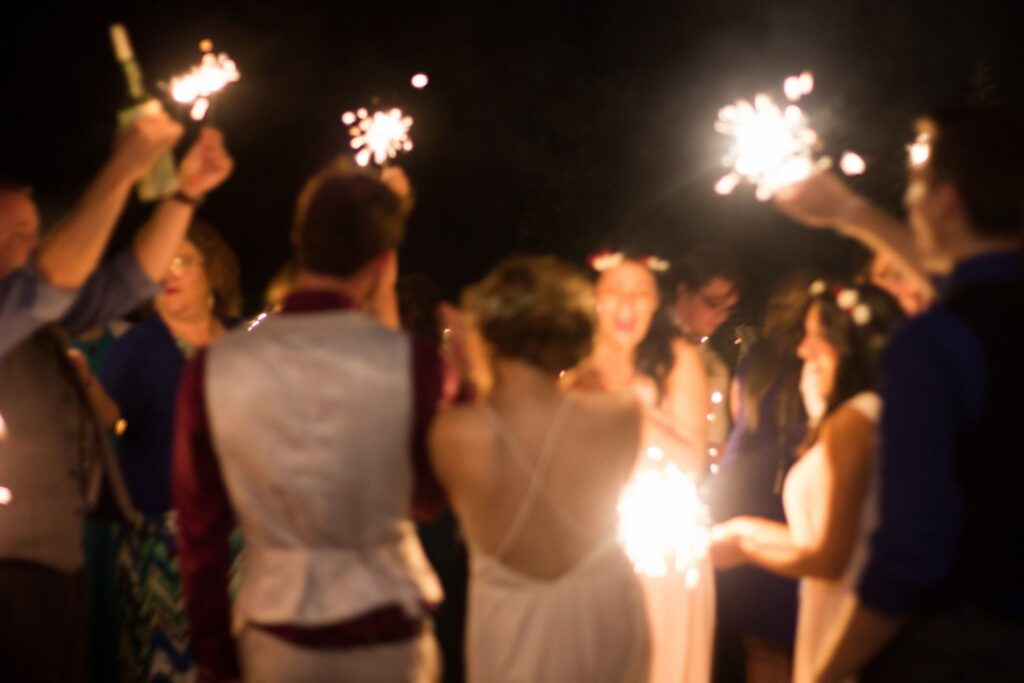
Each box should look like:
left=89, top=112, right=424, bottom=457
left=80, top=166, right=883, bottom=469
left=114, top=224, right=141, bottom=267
left=36, top=162, right=133, bottom=290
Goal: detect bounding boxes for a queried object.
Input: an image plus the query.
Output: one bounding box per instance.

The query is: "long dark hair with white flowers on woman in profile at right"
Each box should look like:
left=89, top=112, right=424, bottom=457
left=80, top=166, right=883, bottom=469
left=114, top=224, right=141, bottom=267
left=804, top=281, right=904, bottom=450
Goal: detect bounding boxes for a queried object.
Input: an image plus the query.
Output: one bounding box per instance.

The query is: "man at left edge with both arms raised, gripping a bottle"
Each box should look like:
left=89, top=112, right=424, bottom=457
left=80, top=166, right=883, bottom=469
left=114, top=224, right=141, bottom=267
left=0, top=113, right=231, bottom=681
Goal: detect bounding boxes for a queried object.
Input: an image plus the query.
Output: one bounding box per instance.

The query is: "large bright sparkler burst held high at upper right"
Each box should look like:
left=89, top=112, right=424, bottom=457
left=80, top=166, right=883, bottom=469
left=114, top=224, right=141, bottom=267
left=715, top=72, right=866, bottom=201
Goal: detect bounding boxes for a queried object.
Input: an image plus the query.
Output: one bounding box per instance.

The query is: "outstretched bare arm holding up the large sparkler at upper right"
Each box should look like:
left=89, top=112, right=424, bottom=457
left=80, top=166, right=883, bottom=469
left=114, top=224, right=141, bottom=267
left=774, top=172, right=935, bottom=309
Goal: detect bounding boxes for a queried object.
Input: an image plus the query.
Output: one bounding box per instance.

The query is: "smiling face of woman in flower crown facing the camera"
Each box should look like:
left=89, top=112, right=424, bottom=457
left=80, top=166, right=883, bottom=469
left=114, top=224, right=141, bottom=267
left=595, top=261, right=657, bottom=350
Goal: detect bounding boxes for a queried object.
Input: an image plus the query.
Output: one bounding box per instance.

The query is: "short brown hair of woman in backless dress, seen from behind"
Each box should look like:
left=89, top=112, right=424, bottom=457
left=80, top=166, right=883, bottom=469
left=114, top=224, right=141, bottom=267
left=463, top=256, right=596, bottom=374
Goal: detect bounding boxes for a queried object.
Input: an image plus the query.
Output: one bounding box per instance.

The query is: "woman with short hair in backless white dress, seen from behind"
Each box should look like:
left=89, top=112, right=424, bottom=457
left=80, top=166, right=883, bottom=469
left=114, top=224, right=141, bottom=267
left=430, top=258, right=649, bottom=683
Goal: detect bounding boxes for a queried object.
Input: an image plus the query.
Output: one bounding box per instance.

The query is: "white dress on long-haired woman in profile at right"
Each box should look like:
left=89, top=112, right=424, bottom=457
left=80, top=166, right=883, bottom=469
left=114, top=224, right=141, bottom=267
left=782, top=391, right=882, bottom=683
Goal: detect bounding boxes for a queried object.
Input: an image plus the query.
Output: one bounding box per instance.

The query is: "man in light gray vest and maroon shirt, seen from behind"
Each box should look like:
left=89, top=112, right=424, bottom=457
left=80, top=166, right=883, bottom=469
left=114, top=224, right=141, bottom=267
left=172, top=161, right=443, bottom=683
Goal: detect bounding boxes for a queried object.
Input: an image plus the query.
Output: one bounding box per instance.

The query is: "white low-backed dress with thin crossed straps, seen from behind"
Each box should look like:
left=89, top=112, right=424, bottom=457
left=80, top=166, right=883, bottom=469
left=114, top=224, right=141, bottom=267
left=466, top=401, right=649, bottom=683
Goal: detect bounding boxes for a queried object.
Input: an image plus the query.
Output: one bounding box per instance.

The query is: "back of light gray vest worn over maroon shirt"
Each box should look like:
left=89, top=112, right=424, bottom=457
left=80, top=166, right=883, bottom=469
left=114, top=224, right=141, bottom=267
left=207, top=308, right=440, bottom=627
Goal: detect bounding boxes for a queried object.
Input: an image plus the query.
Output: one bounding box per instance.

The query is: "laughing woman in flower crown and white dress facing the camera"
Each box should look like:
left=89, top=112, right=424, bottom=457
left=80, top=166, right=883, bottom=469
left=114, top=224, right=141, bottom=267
left=568, top=254, right=715, bottom=683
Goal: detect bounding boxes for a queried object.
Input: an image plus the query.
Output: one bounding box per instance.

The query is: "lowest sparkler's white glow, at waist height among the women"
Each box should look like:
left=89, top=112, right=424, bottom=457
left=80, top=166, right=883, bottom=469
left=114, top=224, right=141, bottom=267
left=618, top=447, right=711, bottom=587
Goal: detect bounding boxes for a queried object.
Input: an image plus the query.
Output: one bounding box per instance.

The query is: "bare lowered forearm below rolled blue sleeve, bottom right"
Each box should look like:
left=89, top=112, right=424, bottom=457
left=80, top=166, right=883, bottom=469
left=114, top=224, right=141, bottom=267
left=814, top=596, right=903, bottom=683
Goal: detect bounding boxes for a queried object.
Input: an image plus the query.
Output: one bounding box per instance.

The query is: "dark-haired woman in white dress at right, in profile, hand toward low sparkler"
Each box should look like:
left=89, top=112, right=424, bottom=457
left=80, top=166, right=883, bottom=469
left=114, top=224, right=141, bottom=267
left=712, top=281, right=902, bottom=683
